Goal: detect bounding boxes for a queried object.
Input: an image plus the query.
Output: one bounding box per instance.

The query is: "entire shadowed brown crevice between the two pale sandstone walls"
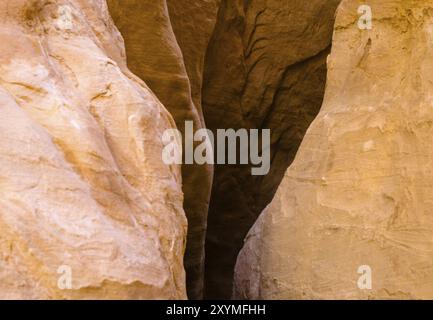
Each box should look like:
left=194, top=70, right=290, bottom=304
left=108, top=0, right=339, bottom=299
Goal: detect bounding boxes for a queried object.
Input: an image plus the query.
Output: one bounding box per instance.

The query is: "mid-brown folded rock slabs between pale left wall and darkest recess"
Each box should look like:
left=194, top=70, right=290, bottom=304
left=108, top=0, right=216, bottom=298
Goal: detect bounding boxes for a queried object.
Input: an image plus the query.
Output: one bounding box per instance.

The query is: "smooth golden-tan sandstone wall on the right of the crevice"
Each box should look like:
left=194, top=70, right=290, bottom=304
left=235, top=0, right=433, bottom=299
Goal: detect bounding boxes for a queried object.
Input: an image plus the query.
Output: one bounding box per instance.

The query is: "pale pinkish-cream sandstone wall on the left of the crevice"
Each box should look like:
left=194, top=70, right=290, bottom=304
left=0, top=0, right=186, bottom=299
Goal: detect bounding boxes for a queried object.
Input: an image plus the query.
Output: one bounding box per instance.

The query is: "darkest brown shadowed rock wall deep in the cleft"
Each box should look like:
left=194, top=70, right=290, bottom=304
left=203, top=0, right=339, bottom=298
